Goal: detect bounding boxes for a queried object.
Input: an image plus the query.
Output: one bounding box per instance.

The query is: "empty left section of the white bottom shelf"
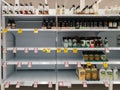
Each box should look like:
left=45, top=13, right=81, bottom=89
left=4, top=70, right=56, bottom=86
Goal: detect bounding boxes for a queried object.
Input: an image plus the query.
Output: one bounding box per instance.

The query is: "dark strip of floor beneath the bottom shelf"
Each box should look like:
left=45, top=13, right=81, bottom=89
left=0, top=85, right=120, bottom=90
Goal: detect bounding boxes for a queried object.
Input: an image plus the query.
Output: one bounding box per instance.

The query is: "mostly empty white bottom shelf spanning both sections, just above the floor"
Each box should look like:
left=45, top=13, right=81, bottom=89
left=4, top=70, right=120, bottom=86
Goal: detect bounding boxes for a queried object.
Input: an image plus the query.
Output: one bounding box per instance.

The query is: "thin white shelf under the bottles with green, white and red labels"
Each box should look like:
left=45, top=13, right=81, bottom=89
left=7, top=47, right=120, bottom=51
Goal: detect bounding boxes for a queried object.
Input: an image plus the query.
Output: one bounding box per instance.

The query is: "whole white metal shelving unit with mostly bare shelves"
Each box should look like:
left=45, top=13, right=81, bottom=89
left=0, top=0, right=120, bottom=90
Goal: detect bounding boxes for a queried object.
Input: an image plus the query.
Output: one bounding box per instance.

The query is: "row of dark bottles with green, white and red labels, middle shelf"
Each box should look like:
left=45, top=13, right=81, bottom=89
left=63, top=36, right=109, bottom=48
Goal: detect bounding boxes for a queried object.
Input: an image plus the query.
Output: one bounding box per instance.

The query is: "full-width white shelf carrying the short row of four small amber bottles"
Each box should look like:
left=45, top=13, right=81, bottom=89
left=7, top=58, right=120, bottom=65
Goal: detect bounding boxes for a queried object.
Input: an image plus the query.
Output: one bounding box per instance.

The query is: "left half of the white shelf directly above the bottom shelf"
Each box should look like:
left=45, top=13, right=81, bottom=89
left=7, top=59, right=56, bottom=65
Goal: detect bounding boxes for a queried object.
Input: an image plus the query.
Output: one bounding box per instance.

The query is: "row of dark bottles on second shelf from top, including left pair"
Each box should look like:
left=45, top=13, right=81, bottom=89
left=6, top=19, right=120, bottom=29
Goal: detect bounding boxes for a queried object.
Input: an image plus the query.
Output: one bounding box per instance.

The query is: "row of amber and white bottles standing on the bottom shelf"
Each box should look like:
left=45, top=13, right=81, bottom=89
left=76, top=65, right=118, bottom=81
